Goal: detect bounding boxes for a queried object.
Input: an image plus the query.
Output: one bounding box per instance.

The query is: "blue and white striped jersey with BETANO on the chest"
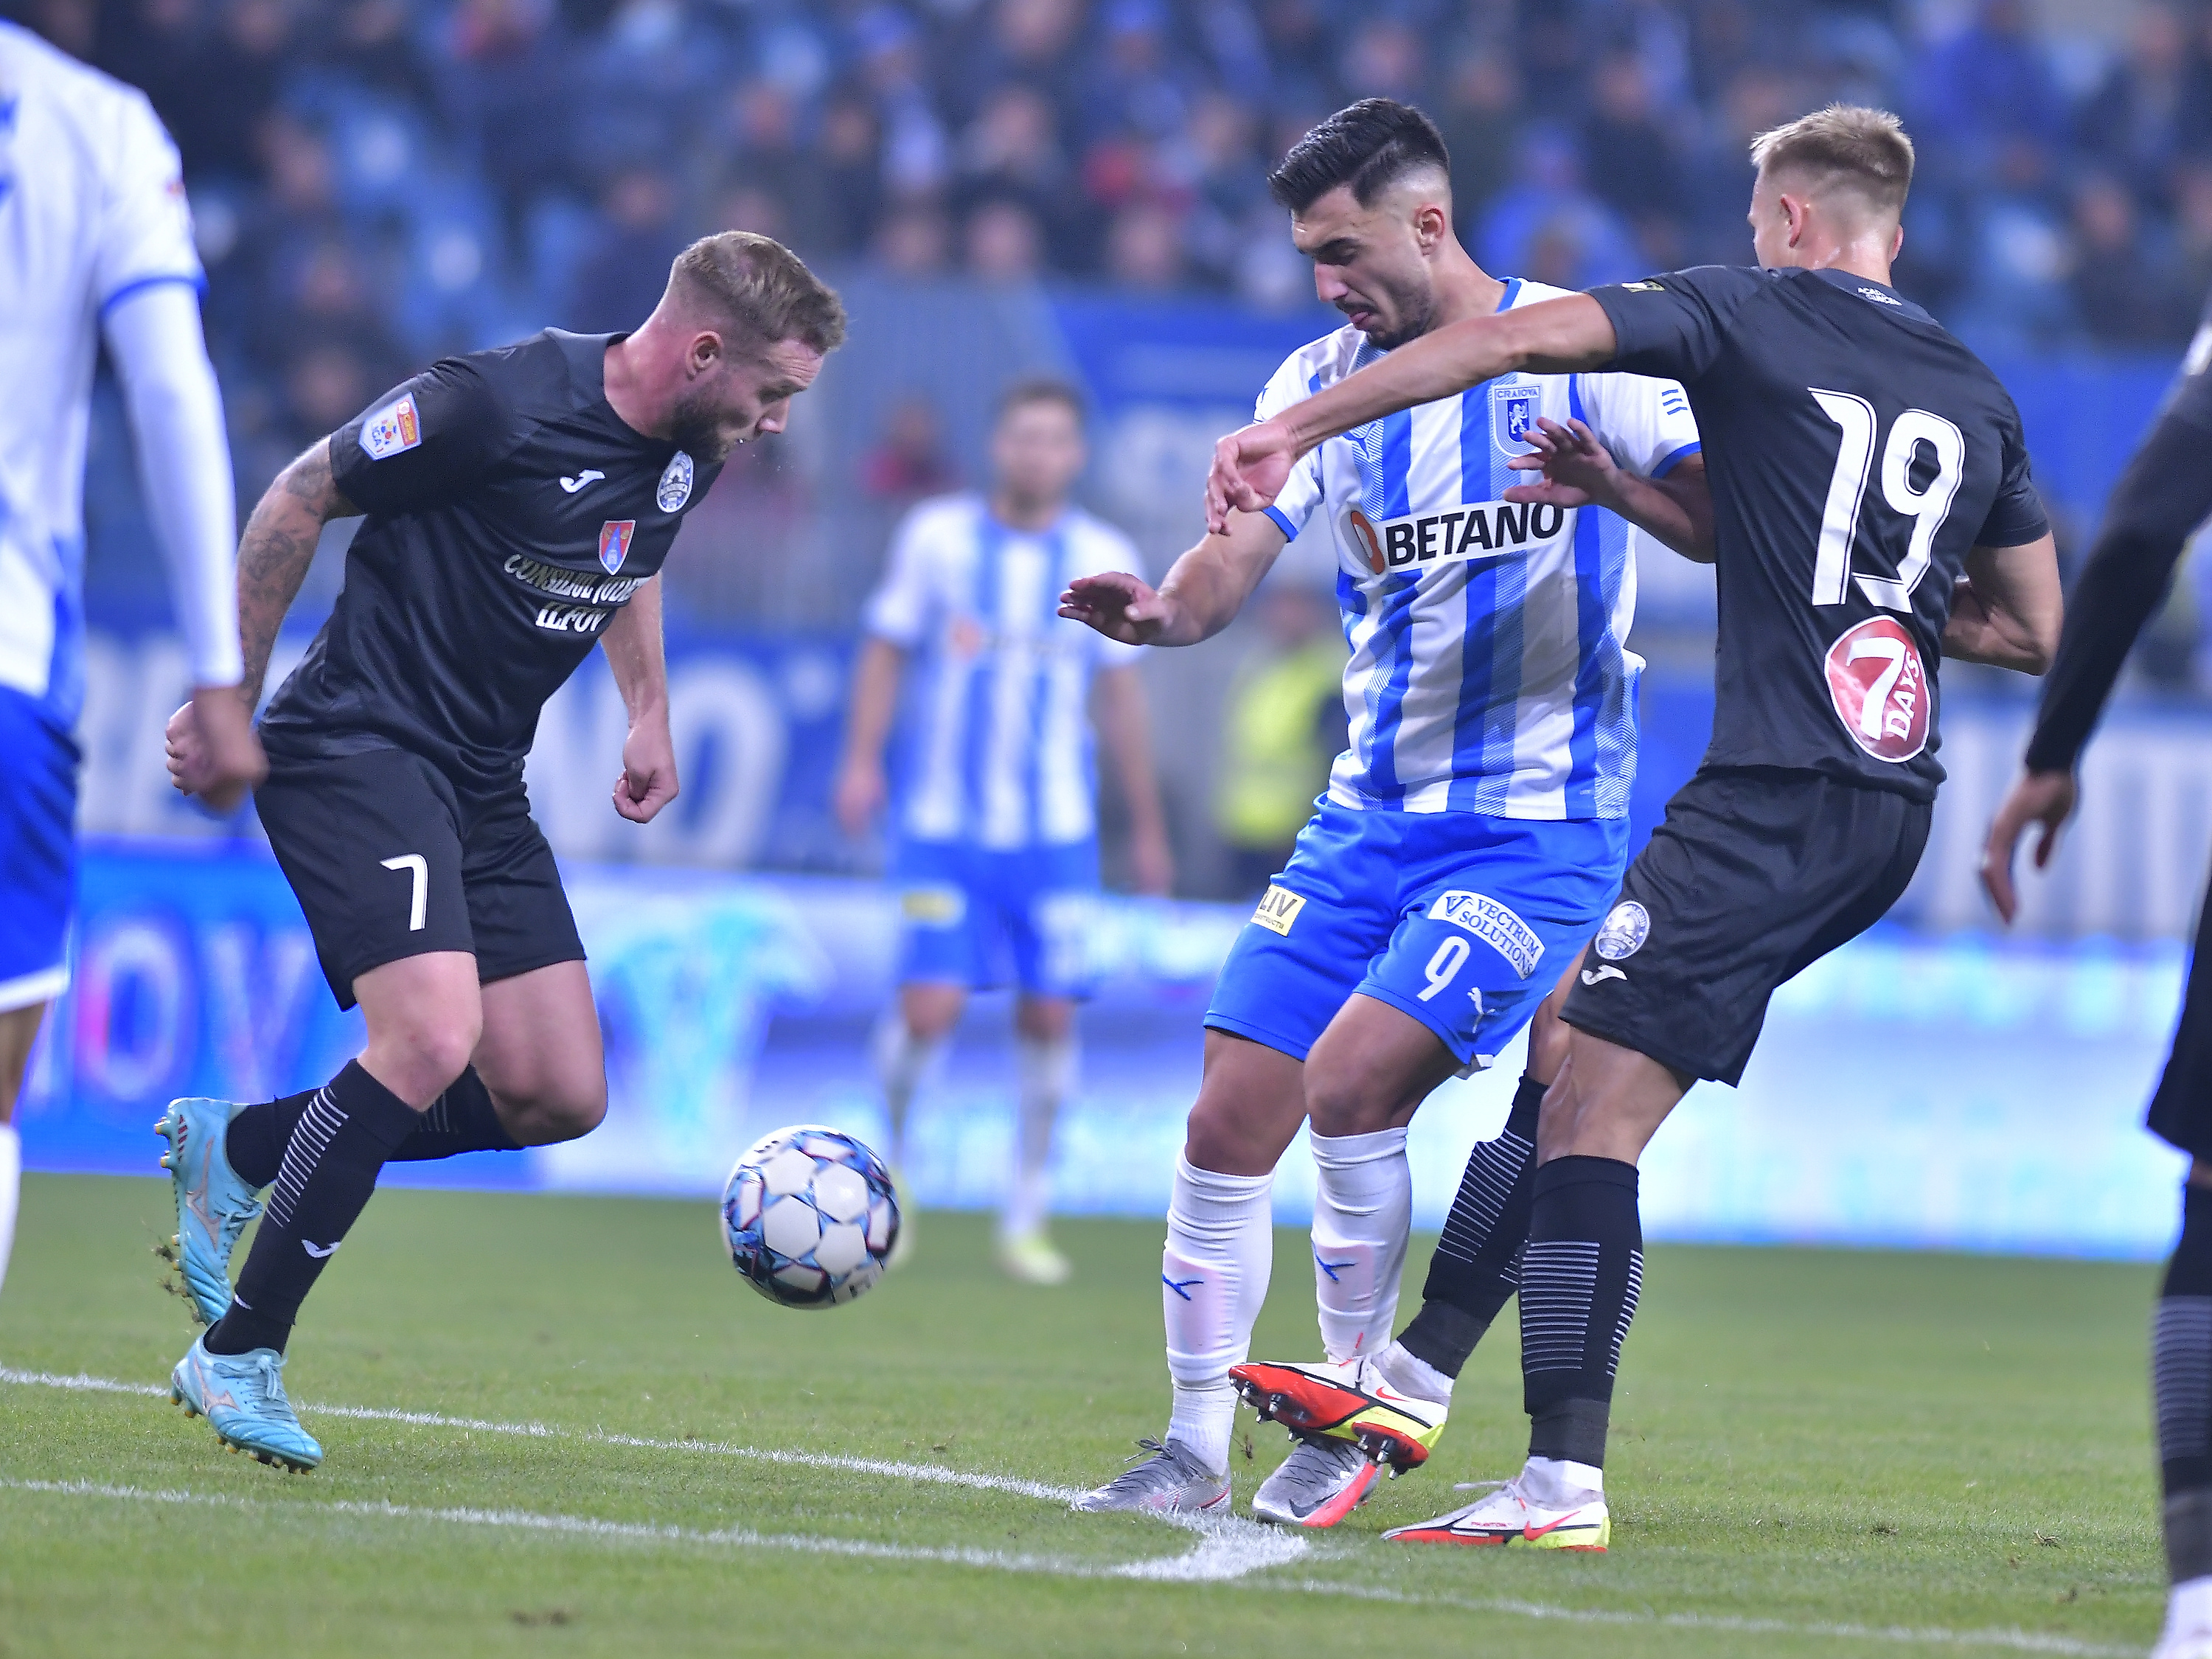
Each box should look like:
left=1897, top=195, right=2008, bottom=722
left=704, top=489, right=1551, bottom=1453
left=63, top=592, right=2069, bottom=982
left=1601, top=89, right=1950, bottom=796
left=1259, top=281, right=1699, bottom=818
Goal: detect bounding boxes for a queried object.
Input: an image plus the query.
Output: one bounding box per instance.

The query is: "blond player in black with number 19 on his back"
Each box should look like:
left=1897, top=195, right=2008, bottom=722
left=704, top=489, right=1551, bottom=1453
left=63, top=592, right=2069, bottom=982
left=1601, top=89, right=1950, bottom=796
left=1208, top=106, right=2059, bottom=1548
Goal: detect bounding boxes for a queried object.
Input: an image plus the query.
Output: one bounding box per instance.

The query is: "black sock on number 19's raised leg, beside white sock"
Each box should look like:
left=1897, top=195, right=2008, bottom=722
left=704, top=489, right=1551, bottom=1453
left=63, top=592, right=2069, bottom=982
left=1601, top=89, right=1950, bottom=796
left=1398, top=1077, right=1546, bottom=1376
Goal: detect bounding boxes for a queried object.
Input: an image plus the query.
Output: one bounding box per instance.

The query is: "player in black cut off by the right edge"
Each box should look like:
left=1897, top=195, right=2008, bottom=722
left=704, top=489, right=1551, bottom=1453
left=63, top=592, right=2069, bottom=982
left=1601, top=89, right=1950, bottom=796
left=1982, top=292, right=2212, bottom=1659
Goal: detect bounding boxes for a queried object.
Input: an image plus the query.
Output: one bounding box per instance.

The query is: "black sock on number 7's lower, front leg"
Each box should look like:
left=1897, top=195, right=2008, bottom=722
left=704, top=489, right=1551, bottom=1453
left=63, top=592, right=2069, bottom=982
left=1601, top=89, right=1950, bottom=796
left=206, top=1060, right=418, bottom=1354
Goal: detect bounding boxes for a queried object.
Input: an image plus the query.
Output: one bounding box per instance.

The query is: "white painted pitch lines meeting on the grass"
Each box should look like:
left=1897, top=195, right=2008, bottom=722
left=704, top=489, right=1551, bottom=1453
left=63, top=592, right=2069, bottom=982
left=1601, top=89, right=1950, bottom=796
left=0, top=1365, right=2141, bottom=1659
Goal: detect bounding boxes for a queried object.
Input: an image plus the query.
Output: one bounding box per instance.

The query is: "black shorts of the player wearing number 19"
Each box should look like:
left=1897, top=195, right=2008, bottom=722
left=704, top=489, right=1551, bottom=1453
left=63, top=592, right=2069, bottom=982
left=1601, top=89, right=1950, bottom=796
left=1564, top=768, right=1933, bottom=1086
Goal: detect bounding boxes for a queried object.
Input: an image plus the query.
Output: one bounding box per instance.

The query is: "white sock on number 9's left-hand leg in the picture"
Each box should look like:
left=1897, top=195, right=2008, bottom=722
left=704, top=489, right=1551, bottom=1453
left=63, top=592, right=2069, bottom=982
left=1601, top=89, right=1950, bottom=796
left=1159, top=1157, right=1274, bottom=1473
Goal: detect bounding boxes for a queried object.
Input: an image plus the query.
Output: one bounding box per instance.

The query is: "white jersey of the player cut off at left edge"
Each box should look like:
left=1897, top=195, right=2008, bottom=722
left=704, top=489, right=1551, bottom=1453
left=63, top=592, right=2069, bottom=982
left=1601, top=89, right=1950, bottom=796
left=0, top=20, right=206, bottom=728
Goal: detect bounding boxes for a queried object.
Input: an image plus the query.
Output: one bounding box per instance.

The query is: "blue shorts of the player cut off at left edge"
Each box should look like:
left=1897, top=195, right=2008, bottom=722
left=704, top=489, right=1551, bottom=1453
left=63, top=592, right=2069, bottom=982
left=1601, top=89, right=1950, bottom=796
left=0, top=688, right=77, bottom=1013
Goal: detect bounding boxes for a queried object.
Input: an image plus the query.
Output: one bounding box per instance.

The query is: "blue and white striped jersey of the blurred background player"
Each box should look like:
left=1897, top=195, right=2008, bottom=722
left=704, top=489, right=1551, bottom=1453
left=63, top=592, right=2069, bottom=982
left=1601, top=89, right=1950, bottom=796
left=867, top=495, right=1144, bottom=849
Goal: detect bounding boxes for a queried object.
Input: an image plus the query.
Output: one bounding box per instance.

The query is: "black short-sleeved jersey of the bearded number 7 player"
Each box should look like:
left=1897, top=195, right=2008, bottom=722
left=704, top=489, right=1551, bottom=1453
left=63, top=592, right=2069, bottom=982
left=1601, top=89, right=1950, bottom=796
left=261, top=330, right=719, bottom=792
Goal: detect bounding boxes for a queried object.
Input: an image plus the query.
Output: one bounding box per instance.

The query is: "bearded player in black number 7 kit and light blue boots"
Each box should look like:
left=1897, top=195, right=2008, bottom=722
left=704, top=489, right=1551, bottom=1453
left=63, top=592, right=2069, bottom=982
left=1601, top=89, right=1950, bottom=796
left=159, top=232, right=845, bottom=1469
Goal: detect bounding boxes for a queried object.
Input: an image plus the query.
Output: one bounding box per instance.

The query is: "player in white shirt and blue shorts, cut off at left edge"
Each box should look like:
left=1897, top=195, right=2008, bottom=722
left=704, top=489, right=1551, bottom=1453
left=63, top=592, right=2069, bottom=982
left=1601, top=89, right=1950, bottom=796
left=0, top=22, right=263, bottom=1310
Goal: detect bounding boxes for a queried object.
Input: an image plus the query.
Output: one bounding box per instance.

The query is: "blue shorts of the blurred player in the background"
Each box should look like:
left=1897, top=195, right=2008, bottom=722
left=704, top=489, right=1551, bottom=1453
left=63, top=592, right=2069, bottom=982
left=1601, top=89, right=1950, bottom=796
left=891, top=841, right=1099, bottom=998
